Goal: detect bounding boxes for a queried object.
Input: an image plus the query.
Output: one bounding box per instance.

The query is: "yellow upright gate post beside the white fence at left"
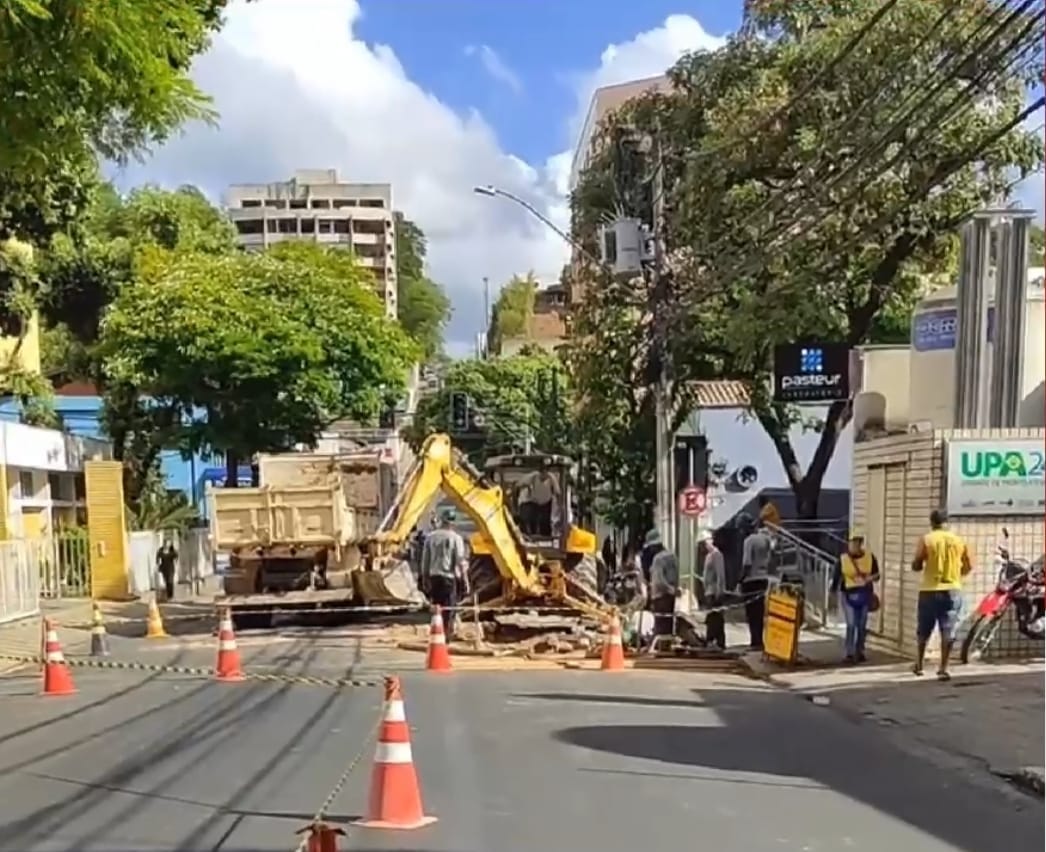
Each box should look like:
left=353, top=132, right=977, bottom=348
left=84, top=461, right=130, bottom=600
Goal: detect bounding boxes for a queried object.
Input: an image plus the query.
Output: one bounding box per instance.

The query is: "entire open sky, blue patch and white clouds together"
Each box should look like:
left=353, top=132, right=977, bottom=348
left=122, top=0, right=1042, bottom=353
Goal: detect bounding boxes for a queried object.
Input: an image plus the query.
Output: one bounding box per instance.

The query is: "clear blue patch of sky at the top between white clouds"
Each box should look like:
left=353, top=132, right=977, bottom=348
left=356, top=0, right=742, bottom=162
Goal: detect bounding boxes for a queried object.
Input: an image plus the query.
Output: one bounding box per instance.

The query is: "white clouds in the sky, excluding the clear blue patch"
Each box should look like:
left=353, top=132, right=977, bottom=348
left=110, top=0, right=711, bottom=352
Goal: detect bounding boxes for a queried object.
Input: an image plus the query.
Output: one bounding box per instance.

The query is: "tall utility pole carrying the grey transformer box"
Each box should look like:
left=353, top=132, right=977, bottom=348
left=651, top=126, right=677, bottom=550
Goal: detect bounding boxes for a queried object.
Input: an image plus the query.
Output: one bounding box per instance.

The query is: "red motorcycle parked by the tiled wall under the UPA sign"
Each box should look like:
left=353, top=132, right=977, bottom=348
left=959, top=527, right=1046, bottom=663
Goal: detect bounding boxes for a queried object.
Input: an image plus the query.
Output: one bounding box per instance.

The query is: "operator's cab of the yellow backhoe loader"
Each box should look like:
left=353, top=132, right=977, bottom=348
left=484, top=453, right=595, bottom=558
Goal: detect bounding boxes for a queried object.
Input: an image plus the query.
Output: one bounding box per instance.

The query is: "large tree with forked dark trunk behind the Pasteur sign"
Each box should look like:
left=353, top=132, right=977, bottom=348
left=574, top=0, right=1042, bottom=515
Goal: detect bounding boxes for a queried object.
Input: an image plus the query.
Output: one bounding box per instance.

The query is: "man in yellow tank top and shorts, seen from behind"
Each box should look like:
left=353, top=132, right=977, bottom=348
left=912, top=509, right=973, bottom=681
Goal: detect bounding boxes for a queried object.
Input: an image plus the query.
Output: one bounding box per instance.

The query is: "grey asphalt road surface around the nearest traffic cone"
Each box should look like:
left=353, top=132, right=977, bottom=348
left=0, top=634, right=1044, bottom=852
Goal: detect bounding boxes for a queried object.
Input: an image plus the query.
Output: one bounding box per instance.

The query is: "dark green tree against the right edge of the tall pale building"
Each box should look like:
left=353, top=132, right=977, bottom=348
left=395, top=212, right=451, bottom=363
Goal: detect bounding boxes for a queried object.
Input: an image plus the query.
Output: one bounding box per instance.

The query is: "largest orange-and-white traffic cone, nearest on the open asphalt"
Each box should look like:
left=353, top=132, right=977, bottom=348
left=356, top=677, right=436, bottom=830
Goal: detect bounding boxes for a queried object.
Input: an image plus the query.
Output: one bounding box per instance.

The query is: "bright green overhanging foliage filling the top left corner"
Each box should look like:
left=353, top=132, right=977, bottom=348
left=0, top=0, right=233, bottom=175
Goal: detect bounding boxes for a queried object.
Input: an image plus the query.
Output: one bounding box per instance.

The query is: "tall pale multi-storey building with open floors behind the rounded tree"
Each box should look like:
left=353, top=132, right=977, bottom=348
left=225, top=168, right=397, bottom=317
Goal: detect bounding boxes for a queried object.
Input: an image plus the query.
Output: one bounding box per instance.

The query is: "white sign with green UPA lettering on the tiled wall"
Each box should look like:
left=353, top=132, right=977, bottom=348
left=947, top=439, right=1046, bottom=515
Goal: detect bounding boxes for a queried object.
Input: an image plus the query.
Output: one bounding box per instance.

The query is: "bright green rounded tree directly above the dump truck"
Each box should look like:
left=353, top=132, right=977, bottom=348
left=99, top=244, right=416, bottom=486
